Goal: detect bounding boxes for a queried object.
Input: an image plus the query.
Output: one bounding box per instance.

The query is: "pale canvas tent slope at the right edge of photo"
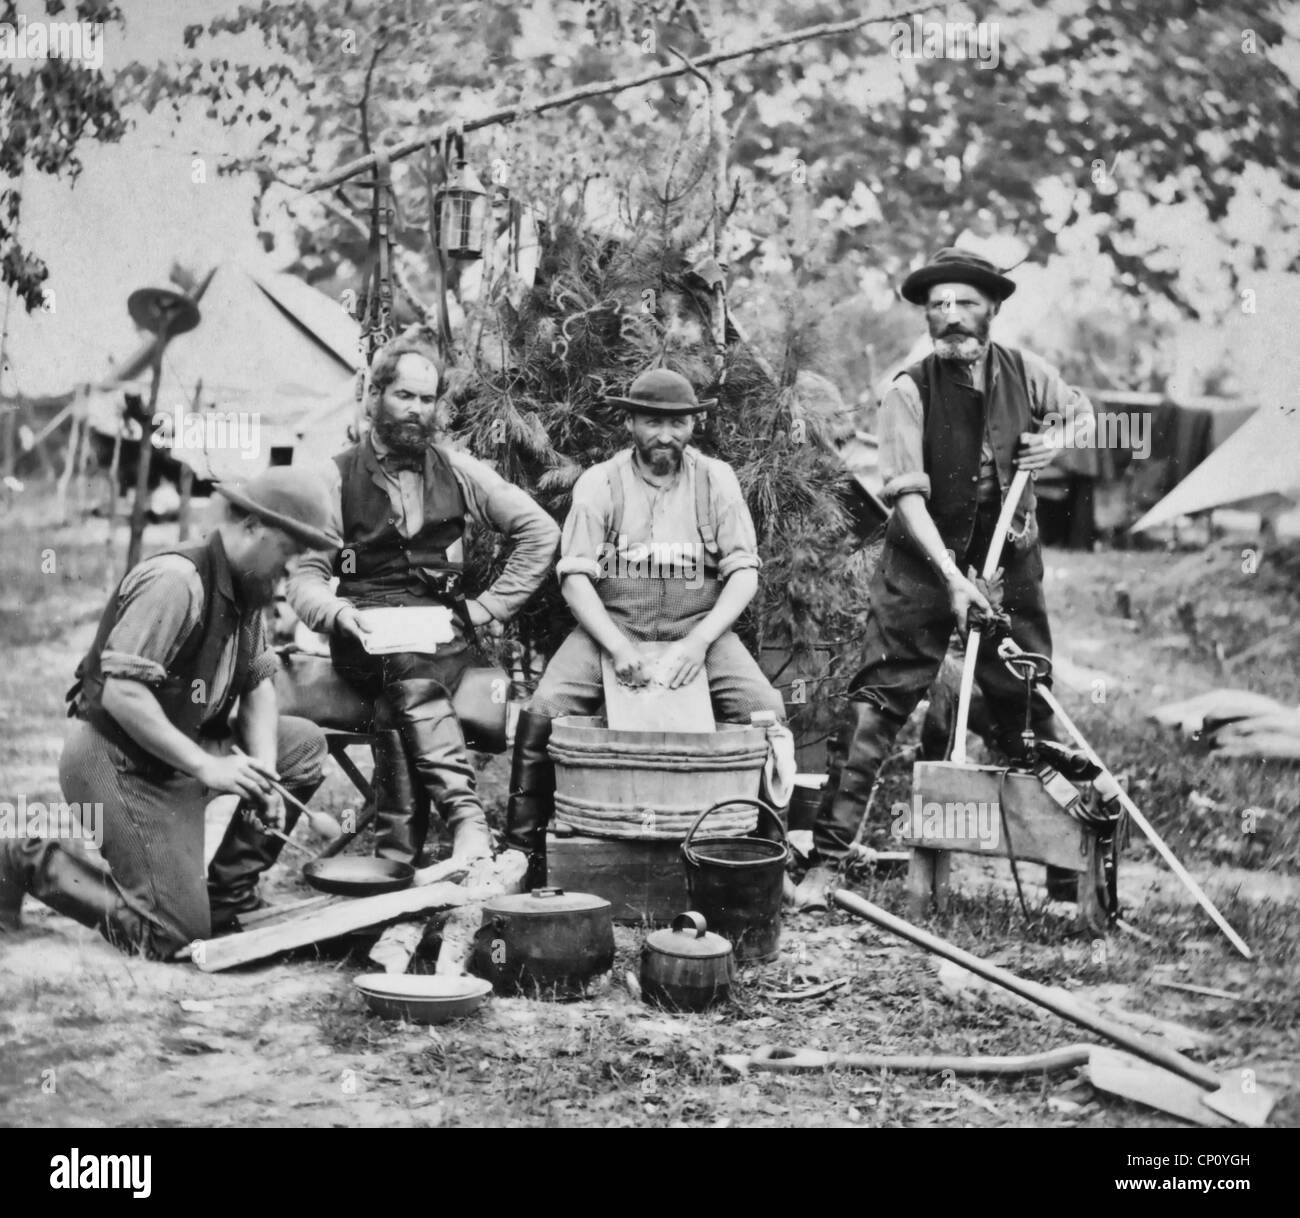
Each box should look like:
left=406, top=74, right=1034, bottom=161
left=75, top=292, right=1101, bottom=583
left=1134, top=404, right=1300, bottom=532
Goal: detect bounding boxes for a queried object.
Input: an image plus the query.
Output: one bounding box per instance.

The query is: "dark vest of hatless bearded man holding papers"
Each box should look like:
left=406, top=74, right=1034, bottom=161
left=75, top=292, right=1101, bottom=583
left=334, top=439, right=465, bottom=604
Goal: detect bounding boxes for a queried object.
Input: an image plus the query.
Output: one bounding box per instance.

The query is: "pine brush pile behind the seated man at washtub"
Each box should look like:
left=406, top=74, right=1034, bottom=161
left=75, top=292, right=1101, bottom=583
left=452, top=204, right=870, bottom=718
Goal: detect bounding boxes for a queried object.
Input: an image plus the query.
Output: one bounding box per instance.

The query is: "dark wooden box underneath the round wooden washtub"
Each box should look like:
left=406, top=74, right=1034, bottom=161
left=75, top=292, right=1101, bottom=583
left=546, top=835, right=690, bottom=924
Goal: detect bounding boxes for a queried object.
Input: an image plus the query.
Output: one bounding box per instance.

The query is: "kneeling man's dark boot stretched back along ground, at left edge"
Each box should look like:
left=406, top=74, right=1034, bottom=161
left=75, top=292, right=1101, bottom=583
left=0, top=837, right=172, bottom=959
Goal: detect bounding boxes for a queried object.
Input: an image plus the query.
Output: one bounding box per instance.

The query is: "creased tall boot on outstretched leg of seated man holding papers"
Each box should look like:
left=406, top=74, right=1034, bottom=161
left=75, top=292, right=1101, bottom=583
left=385, top=679, right=491, bottom=862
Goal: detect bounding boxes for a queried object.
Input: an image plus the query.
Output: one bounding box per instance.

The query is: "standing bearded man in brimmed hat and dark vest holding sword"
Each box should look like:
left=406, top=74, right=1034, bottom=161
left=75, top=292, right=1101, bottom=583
left=798, top=250, right=1092, bottom=906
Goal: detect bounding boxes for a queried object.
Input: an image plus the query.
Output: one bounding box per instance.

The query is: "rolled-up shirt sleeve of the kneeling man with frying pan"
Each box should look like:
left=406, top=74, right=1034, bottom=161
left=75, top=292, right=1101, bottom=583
left=100, top=554, right=203, bottom=686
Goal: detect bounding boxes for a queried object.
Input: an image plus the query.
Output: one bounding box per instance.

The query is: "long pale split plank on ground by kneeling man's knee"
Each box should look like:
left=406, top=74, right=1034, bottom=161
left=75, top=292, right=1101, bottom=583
left=192, top=883, right=491, bottom=972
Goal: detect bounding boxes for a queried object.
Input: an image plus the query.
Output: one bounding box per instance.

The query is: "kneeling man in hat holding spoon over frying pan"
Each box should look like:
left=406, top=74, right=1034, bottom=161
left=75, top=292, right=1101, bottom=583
left=0, top=467, right=338, bottom=959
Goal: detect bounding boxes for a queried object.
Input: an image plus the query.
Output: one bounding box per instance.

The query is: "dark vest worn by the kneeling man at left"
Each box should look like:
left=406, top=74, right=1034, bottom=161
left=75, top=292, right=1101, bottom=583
left=68, top=533, right=251, bottom=770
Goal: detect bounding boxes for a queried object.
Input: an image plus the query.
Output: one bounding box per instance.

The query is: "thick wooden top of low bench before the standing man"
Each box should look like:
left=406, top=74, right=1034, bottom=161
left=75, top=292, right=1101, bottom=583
left=898, top=762, right=1092, bottom=872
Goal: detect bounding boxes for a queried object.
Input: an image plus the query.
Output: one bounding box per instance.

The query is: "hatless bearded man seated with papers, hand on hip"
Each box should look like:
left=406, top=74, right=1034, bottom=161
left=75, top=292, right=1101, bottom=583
left=289, top=335, right=559, bottom=863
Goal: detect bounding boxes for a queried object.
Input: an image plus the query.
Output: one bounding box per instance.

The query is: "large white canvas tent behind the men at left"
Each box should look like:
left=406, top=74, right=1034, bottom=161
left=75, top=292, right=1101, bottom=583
left=101, top=263, right=361, bottom=480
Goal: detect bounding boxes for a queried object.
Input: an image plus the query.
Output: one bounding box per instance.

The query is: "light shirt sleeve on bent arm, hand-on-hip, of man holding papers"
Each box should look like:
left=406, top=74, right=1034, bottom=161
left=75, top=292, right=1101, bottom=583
left=445, top=448, right=560, bottom=621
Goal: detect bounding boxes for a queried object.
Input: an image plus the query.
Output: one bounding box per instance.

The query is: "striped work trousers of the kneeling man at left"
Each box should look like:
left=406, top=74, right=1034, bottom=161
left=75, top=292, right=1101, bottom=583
left=53, top=715, right=325, bottom=959
